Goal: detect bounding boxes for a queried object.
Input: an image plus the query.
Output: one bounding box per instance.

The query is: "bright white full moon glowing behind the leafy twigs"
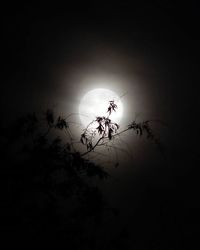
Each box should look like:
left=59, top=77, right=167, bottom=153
left=79, top=88, right=123, bottom=127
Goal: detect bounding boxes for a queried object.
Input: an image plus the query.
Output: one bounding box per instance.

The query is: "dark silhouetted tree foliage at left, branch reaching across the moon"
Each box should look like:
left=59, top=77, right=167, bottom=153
left=1, top=101, right=163, bottom=250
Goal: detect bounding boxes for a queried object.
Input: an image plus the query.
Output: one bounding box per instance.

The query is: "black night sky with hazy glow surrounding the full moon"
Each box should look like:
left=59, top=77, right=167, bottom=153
left=0, top=0, right=200, bottom=249
